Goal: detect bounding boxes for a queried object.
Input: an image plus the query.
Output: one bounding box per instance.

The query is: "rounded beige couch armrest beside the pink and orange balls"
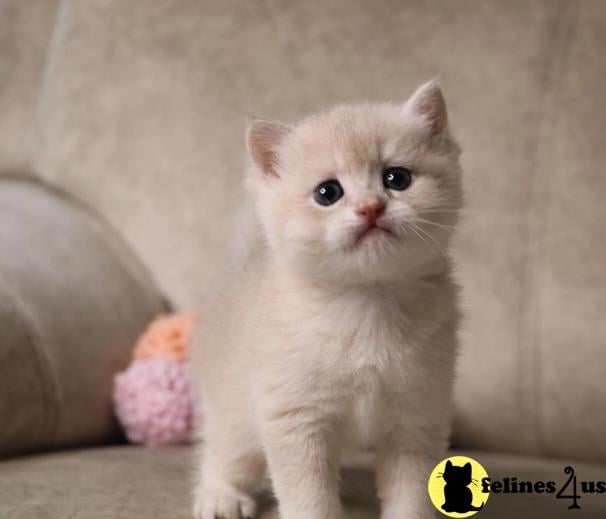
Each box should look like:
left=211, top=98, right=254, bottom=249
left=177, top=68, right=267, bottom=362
left=0, top=176, right=163, bottom=456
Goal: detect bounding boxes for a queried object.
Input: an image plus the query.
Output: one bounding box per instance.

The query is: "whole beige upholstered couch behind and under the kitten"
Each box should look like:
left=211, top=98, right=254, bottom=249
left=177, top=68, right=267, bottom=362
left=0, top=0, right=606, bottom=519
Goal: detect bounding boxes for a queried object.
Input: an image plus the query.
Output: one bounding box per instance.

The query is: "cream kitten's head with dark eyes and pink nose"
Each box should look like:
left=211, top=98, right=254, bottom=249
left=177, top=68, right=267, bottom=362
left=247, top=81, right=461, bottom=282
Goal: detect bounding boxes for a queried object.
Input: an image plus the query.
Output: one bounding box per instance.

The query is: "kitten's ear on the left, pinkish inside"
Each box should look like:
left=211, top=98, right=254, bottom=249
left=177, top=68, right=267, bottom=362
left=246, top=117, right=291, bottom=177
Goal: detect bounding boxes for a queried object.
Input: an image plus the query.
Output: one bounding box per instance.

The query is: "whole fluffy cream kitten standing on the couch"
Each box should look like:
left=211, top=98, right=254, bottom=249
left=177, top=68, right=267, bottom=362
left=193, top=82, right=461, bottom=519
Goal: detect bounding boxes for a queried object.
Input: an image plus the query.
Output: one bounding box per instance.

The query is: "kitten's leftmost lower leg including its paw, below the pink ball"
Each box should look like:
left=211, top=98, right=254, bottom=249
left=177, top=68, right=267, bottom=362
left=193, top=424, right=265, bottom=519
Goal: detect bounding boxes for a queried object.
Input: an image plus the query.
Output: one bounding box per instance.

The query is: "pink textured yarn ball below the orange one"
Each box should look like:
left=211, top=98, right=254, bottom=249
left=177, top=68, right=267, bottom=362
left=113, top=357, right=194, bottom=445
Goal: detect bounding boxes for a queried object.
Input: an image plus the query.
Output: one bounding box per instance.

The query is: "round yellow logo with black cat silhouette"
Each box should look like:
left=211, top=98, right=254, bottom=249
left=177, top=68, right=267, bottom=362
left=427, top=456, right=490, bottom=517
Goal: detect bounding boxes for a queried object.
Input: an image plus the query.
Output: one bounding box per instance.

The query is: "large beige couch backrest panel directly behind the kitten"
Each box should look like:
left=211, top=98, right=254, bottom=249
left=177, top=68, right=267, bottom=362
left=35, top=0, right=606, bottom=460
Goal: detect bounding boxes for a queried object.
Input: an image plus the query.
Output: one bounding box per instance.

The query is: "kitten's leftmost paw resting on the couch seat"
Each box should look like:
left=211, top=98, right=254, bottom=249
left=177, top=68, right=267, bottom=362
left=194, top=489, right=257, bottom=519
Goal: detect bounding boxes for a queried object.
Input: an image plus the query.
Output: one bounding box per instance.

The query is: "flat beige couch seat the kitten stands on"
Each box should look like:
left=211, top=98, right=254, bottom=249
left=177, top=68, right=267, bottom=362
left=0, top=447, right=606, bottom=519
